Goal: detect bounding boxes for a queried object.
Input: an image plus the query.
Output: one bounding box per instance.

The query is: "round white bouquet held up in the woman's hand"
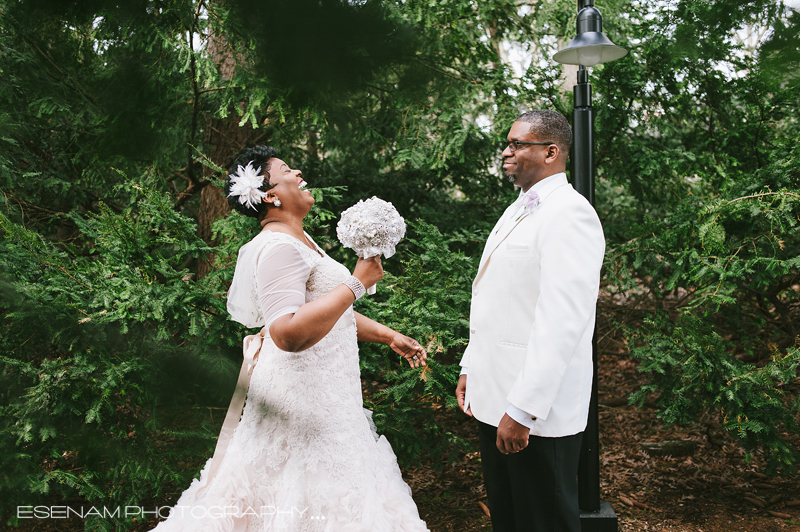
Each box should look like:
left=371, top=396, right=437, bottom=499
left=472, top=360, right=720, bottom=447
left=336, top=196, right=406, bottom=294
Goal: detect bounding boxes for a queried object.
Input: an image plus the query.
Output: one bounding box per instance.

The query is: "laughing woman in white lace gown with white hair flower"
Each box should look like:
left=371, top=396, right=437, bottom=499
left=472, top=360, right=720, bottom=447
left=154, top=146, right=434, bottom=532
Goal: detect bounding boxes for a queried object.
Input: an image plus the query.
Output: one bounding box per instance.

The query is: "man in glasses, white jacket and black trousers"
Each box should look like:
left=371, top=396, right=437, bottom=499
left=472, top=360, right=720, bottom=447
left=456, top=111, right=605, bottom=532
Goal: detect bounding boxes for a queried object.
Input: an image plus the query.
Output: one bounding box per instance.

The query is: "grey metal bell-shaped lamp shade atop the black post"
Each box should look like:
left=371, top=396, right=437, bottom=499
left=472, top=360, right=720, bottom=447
left=553, top=7, right=628, bottom=66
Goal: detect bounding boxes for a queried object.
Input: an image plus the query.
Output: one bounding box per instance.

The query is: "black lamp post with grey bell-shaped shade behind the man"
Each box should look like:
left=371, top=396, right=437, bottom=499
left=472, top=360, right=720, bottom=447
left=553, top=0, right=628, bottom=532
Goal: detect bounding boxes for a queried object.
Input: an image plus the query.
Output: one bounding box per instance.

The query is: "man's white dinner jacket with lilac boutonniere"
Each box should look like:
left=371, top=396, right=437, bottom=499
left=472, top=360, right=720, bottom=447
left=461, top=173, right=605, bottom=437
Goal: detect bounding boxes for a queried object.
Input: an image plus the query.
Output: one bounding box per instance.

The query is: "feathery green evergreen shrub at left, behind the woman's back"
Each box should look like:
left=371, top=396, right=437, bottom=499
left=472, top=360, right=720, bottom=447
left=0, top=181, right=238, bottom=526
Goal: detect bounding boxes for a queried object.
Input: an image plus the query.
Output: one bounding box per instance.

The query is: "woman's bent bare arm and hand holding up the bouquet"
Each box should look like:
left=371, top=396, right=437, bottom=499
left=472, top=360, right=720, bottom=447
left=265, top=257, right=383, bottom=352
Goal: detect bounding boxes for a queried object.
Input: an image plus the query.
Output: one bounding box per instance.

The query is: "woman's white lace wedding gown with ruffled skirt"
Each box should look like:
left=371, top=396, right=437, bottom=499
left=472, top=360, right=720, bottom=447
left=154, top=231, right=427, bottom=532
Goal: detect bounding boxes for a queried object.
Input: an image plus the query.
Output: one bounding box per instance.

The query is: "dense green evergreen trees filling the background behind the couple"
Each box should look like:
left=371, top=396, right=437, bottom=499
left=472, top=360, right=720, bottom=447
left=0, top=0, right=800, bottom=530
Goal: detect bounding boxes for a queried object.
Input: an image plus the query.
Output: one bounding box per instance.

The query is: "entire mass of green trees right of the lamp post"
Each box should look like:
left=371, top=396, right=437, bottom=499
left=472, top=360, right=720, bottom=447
left=595, top=0, right=800, bottom=472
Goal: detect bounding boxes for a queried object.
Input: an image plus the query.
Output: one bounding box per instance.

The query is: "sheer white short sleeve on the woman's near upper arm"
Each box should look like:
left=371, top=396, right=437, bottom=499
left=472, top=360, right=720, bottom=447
left=256, top=243, right=311, bottom=329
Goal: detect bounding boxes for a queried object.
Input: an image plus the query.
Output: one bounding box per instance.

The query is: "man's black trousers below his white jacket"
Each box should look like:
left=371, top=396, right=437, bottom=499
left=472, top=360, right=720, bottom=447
left=478, top=421, right=583, bottom=532
